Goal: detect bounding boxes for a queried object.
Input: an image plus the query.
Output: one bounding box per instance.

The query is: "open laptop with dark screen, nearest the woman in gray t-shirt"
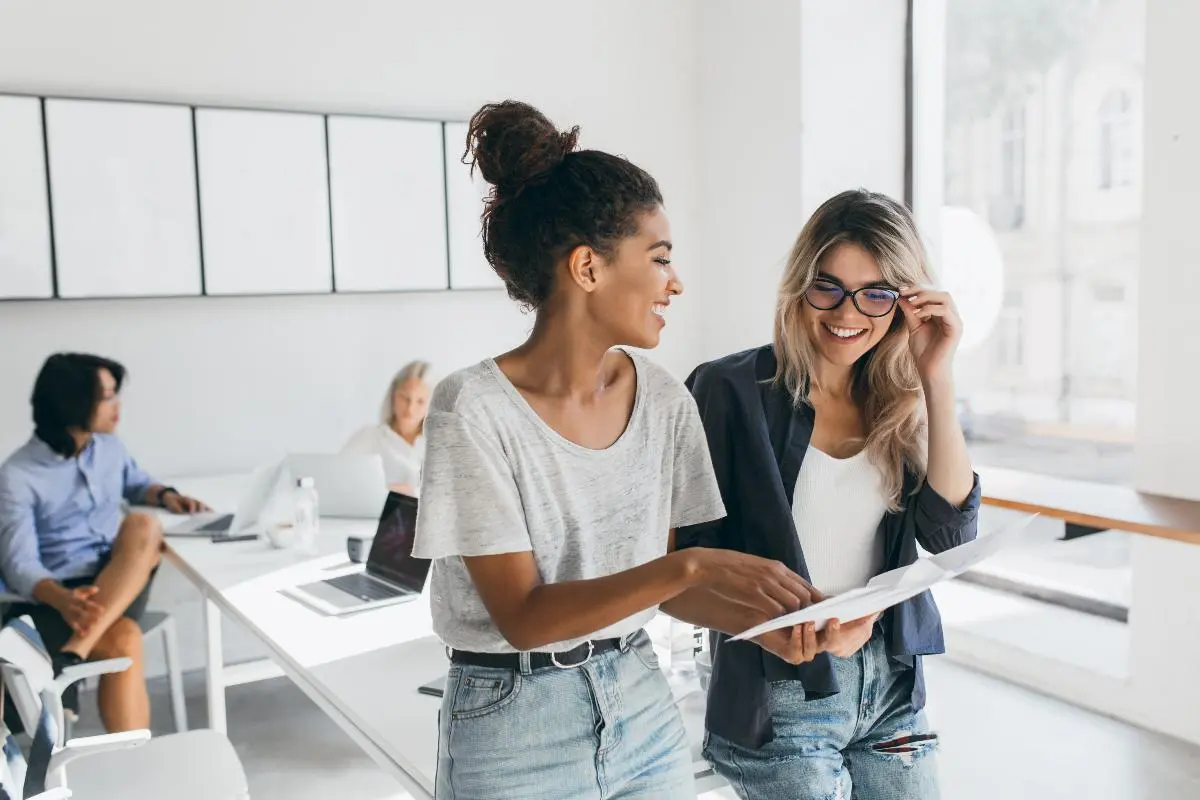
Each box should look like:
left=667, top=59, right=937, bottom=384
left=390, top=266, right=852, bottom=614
left=282, top=492, right=430, bottom=615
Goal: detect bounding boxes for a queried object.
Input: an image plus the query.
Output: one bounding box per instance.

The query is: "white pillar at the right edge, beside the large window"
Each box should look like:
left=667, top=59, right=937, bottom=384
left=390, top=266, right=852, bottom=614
left=1132, top=0, right=1200, bottom=742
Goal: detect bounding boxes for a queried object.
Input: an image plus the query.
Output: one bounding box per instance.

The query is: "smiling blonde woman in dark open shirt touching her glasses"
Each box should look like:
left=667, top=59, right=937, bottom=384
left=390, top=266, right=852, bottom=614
left=673, top=191, right=979, bottom=800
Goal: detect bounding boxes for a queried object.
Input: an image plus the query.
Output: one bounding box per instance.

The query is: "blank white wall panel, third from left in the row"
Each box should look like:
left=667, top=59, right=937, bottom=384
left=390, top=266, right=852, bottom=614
left=196, top=108, right=332, bottom=295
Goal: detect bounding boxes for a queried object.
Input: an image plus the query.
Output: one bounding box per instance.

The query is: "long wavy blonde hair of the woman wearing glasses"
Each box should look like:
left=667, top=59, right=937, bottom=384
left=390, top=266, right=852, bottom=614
left=775, top=190, right=932, bottom=510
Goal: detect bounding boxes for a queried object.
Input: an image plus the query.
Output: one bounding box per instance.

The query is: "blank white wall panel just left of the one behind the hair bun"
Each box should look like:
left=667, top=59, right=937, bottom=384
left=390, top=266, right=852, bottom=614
left=328, top=115, right=449, bottom=291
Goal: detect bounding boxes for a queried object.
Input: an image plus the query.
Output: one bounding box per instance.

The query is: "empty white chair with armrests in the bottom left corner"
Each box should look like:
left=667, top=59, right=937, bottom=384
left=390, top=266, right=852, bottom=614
left=0, top=616, right=250, bottom=800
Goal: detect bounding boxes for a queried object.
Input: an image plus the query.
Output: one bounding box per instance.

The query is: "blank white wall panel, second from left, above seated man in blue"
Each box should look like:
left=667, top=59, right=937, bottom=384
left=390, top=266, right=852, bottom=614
left=46, top=98, right=200, bottom=297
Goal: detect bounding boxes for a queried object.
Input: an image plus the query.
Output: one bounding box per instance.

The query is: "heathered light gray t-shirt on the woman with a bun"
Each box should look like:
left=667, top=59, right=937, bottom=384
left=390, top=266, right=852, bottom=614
left=414, top=353, right=725, bottom=652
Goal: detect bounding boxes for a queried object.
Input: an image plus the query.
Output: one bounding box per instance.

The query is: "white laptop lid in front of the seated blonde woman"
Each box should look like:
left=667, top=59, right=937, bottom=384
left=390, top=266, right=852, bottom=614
left=283, top=453, right=388, bottom=519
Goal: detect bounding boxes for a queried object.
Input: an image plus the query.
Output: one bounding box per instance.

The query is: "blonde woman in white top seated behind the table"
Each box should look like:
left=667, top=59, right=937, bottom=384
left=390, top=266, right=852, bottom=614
left=342, top=361, right=432, bottom=497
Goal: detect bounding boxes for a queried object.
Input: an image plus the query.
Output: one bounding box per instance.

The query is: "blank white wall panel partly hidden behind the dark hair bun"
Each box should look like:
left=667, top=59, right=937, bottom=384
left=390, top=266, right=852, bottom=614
left=443, top=122, right=504, bottom=289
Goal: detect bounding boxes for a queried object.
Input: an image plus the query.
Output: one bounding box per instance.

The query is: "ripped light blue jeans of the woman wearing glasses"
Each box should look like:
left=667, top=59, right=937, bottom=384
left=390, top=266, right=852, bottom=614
left=704, top=632, right=940, bottom=800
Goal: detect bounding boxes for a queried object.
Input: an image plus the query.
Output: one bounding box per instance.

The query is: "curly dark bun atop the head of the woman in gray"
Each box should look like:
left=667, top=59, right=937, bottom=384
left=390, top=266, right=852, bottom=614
left=464, top=100, right=580, bottom=197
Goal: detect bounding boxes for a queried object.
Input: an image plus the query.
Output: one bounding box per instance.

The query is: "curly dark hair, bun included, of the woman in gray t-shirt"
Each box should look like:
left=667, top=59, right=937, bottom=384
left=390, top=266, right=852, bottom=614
left=463, top=100, right=662, bottom=309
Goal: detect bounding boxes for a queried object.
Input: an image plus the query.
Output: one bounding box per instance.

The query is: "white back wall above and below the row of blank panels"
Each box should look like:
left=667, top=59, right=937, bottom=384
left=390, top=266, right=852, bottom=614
left=0, top=0, right=700, bottom=475
